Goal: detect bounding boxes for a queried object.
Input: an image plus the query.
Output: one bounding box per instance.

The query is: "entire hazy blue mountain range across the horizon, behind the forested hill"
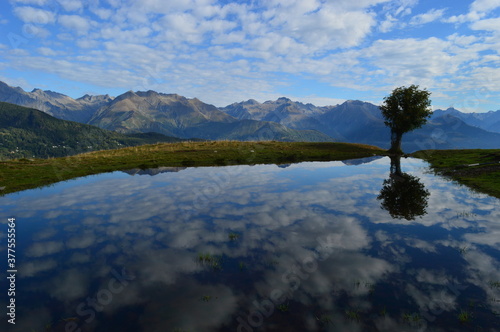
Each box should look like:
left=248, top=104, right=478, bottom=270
left=0, top=82, right=500, bottom=156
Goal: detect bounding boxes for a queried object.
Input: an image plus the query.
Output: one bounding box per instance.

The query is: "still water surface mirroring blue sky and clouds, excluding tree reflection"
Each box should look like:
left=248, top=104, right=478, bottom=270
left=0, top=158, right=500, bottom=331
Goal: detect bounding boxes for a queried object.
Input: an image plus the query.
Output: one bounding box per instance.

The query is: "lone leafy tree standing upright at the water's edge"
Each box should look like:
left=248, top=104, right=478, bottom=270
left=380, top=85, right=432, bottom=155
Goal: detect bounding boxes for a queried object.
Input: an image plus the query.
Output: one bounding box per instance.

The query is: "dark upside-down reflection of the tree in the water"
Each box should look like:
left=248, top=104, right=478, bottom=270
left=377, top=156, right=430, bottom=220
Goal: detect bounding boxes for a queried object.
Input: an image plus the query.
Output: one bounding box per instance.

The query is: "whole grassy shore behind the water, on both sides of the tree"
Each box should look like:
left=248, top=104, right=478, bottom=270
left=0, top=141, right=500, bottom=198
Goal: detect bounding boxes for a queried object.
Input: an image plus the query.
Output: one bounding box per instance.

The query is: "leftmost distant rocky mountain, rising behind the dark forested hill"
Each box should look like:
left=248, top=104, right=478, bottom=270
left=0, top=82, right=113, bottom=123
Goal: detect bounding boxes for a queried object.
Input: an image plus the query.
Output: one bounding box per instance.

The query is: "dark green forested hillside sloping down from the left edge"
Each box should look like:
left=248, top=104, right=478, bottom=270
left=0, top=102, right=181, bottom=159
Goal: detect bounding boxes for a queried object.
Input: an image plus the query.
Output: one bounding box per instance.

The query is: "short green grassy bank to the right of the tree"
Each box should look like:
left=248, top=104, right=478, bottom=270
left=411, top=149, right=500, bottom=198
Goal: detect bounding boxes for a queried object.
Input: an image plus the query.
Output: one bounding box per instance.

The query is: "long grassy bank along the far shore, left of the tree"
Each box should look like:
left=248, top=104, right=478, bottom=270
left=0, top=141, right=385, bottom=195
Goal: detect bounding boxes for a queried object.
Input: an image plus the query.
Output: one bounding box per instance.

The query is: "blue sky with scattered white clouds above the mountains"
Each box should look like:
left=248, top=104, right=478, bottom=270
left=0, top=0, right=500, bottom=112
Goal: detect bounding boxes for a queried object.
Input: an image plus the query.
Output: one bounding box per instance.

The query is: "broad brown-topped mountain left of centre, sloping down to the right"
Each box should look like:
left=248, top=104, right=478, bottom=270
left=89, top=91, right=332, bottom=141
